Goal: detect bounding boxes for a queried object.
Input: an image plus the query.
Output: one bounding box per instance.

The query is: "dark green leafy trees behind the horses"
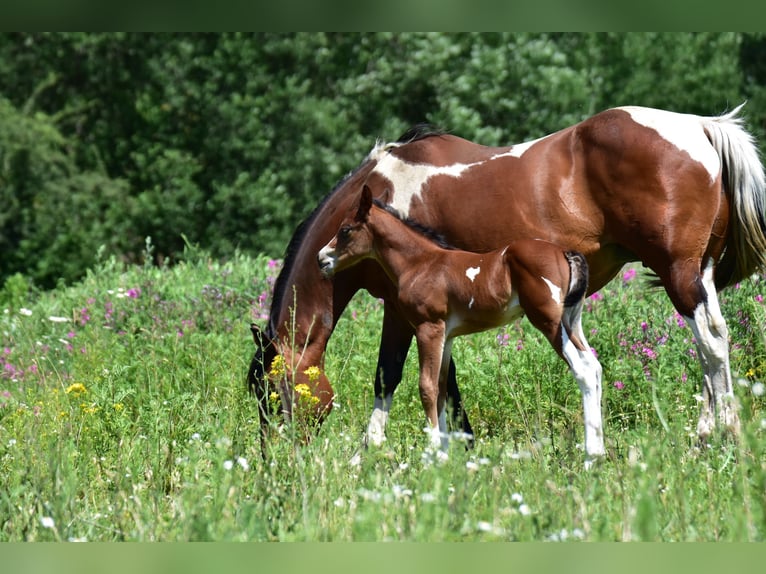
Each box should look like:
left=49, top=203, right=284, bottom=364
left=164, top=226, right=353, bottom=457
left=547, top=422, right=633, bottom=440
left=0, top=33, right=766, bottom=289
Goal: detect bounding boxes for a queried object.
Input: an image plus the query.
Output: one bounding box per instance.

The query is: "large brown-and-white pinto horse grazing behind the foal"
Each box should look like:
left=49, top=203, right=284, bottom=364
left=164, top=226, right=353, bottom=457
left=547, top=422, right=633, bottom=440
left=248, top=102, right=766, bottom=454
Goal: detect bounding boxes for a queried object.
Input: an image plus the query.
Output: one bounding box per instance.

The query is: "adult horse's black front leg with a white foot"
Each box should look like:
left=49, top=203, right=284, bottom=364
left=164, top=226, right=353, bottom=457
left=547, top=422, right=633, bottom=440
left=364, top=303, right=413, bottom=446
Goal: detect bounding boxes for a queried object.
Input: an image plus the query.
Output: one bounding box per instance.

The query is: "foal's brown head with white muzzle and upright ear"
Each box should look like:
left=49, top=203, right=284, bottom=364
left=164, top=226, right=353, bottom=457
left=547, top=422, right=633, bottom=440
left=317, top=185, right=373, bottom=277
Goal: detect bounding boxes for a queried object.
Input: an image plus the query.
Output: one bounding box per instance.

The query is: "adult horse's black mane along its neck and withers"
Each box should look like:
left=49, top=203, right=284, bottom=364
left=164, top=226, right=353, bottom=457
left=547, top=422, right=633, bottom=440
left=266, top=124, right=445, bottom=339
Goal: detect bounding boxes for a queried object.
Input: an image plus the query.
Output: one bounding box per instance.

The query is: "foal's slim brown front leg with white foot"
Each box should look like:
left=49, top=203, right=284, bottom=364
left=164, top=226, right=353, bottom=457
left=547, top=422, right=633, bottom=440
left=415, top=321, right=446, bottom=450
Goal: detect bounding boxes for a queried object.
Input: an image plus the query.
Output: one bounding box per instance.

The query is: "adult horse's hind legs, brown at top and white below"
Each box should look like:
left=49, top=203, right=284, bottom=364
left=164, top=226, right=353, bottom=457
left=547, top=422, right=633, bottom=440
left=666, top=260, right=739, bottom=441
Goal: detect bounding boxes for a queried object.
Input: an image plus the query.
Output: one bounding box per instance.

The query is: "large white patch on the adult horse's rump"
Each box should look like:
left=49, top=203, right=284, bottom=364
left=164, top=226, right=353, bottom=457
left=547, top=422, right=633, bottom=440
left=617, top=106, right=721, bottom=180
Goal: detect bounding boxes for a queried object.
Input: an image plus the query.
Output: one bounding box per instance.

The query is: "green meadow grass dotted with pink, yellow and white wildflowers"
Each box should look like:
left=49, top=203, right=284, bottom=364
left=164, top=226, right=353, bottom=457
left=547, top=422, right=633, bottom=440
left=0, top=245, right=766, bottom=541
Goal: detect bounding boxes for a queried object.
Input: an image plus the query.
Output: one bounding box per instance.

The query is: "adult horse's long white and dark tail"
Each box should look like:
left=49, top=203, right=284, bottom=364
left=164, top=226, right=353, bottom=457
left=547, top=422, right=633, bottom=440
left=702, top=103, right=766, bottom=289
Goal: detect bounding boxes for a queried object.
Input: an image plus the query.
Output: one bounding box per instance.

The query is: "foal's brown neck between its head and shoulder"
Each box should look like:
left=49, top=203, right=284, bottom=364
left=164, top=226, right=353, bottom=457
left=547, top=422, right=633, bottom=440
left=370, top=210, right=442, bottom=283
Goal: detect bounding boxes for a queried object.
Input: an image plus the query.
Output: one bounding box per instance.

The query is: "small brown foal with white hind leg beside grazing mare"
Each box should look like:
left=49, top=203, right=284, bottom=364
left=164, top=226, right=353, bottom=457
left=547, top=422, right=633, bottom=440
left=318, top=186, right=604, bottom=465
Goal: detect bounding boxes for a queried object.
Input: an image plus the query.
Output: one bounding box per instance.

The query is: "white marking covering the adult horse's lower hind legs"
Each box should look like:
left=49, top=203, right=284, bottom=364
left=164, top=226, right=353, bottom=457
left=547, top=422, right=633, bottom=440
left=684, top=264, right=739, bottom=439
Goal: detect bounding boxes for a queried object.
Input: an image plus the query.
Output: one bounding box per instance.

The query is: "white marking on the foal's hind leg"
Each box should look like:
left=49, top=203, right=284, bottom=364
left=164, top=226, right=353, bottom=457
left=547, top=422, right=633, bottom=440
left=562, top=317, right=606, bottom=468
